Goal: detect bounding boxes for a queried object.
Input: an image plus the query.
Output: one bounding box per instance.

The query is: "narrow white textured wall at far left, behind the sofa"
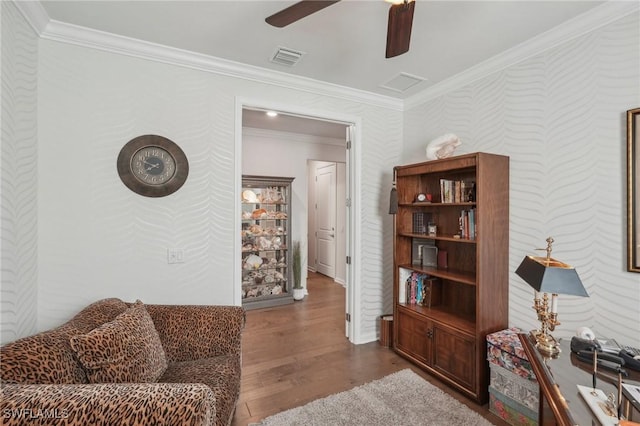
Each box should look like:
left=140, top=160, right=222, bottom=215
left=0, top=1, right=38, bottom=343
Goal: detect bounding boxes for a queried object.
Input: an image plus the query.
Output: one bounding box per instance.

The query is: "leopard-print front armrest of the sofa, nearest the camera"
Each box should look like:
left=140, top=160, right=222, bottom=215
left=0, top=383, right=215, bottom=426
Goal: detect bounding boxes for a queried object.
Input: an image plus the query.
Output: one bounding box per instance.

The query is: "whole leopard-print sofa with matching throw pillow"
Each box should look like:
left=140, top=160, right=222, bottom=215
left=0, top=298, right=245, bottom=426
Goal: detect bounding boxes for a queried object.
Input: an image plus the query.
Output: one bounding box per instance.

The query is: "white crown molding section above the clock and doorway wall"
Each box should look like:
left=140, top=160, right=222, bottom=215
left=35, top=20, right=403, bottom=111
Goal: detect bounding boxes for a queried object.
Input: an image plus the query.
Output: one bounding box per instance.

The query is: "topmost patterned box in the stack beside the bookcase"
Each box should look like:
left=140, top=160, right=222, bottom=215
left=487, top=327, right=536, bottom=381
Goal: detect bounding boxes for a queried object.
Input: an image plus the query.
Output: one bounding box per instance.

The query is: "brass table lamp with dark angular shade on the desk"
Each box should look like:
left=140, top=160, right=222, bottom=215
left=516, top=237, right=589, bottom=356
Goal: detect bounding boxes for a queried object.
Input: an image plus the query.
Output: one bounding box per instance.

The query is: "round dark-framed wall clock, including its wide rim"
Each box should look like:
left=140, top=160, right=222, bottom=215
left=118, top=135, right=189, bottom=197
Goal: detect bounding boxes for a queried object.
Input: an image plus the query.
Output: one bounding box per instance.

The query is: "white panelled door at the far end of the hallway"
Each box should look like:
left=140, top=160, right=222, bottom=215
left=316, top=163, right=336, bottom=278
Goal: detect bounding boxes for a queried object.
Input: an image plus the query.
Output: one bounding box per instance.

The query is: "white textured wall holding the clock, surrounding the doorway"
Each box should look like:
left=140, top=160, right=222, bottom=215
left=38, top=40, right=402, bottom=341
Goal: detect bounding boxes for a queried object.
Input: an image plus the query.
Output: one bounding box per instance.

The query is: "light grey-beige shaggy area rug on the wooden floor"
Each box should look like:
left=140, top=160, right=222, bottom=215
left=257, top=369, right=491, bottom=426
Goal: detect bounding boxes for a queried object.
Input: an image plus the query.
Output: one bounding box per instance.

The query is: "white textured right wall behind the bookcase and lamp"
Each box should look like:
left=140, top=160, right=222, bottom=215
left=403, top=13, right=640, bottom=346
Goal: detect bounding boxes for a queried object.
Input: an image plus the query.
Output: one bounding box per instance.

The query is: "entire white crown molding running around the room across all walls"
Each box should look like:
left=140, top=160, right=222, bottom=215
left=14, top=0, right=640, bottom=111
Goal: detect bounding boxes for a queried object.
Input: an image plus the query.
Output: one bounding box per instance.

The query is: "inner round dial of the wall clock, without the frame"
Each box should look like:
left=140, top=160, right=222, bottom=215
left=131, top=146, right=176, bottom=185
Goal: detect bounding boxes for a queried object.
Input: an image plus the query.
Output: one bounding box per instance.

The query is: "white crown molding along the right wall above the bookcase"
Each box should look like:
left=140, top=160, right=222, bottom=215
left=404, top=0, right=640, bottom=111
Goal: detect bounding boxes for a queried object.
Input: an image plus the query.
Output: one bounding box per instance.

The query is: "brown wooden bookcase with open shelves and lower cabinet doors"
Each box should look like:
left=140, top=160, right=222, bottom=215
left=393, top=153, right=509, bottom=404
